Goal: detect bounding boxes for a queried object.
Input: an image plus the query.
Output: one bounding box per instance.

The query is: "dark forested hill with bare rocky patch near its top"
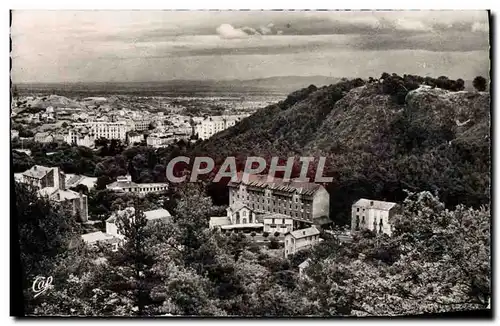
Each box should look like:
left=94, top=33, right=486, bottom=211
left=188, top=74, right=490, bottom=224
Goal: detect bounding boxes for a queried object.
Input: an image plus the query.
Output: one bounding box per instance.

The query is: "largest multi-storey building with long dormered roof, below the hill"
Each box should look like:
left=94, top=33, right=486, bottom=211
left=210, top=173, right=330, bottom=234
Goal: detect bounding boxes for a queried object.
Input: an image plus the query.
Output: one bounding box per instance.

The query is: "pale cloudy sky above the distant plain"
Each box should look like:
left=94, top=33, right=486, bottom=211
left=11, top=10, right=490, bottom=83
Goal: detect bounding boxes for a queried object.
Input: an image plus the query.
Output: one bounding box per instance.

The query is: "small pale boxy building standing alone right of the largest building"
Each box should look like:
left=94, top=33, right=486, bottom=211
left=351, top=198, right=398, bottom=235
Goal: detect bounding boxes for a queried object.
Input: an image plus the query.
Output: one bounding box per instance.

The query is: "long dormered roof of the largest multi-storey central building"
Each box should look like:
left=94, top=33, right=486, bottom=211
left=228, top=172, right=321, bottom=196
